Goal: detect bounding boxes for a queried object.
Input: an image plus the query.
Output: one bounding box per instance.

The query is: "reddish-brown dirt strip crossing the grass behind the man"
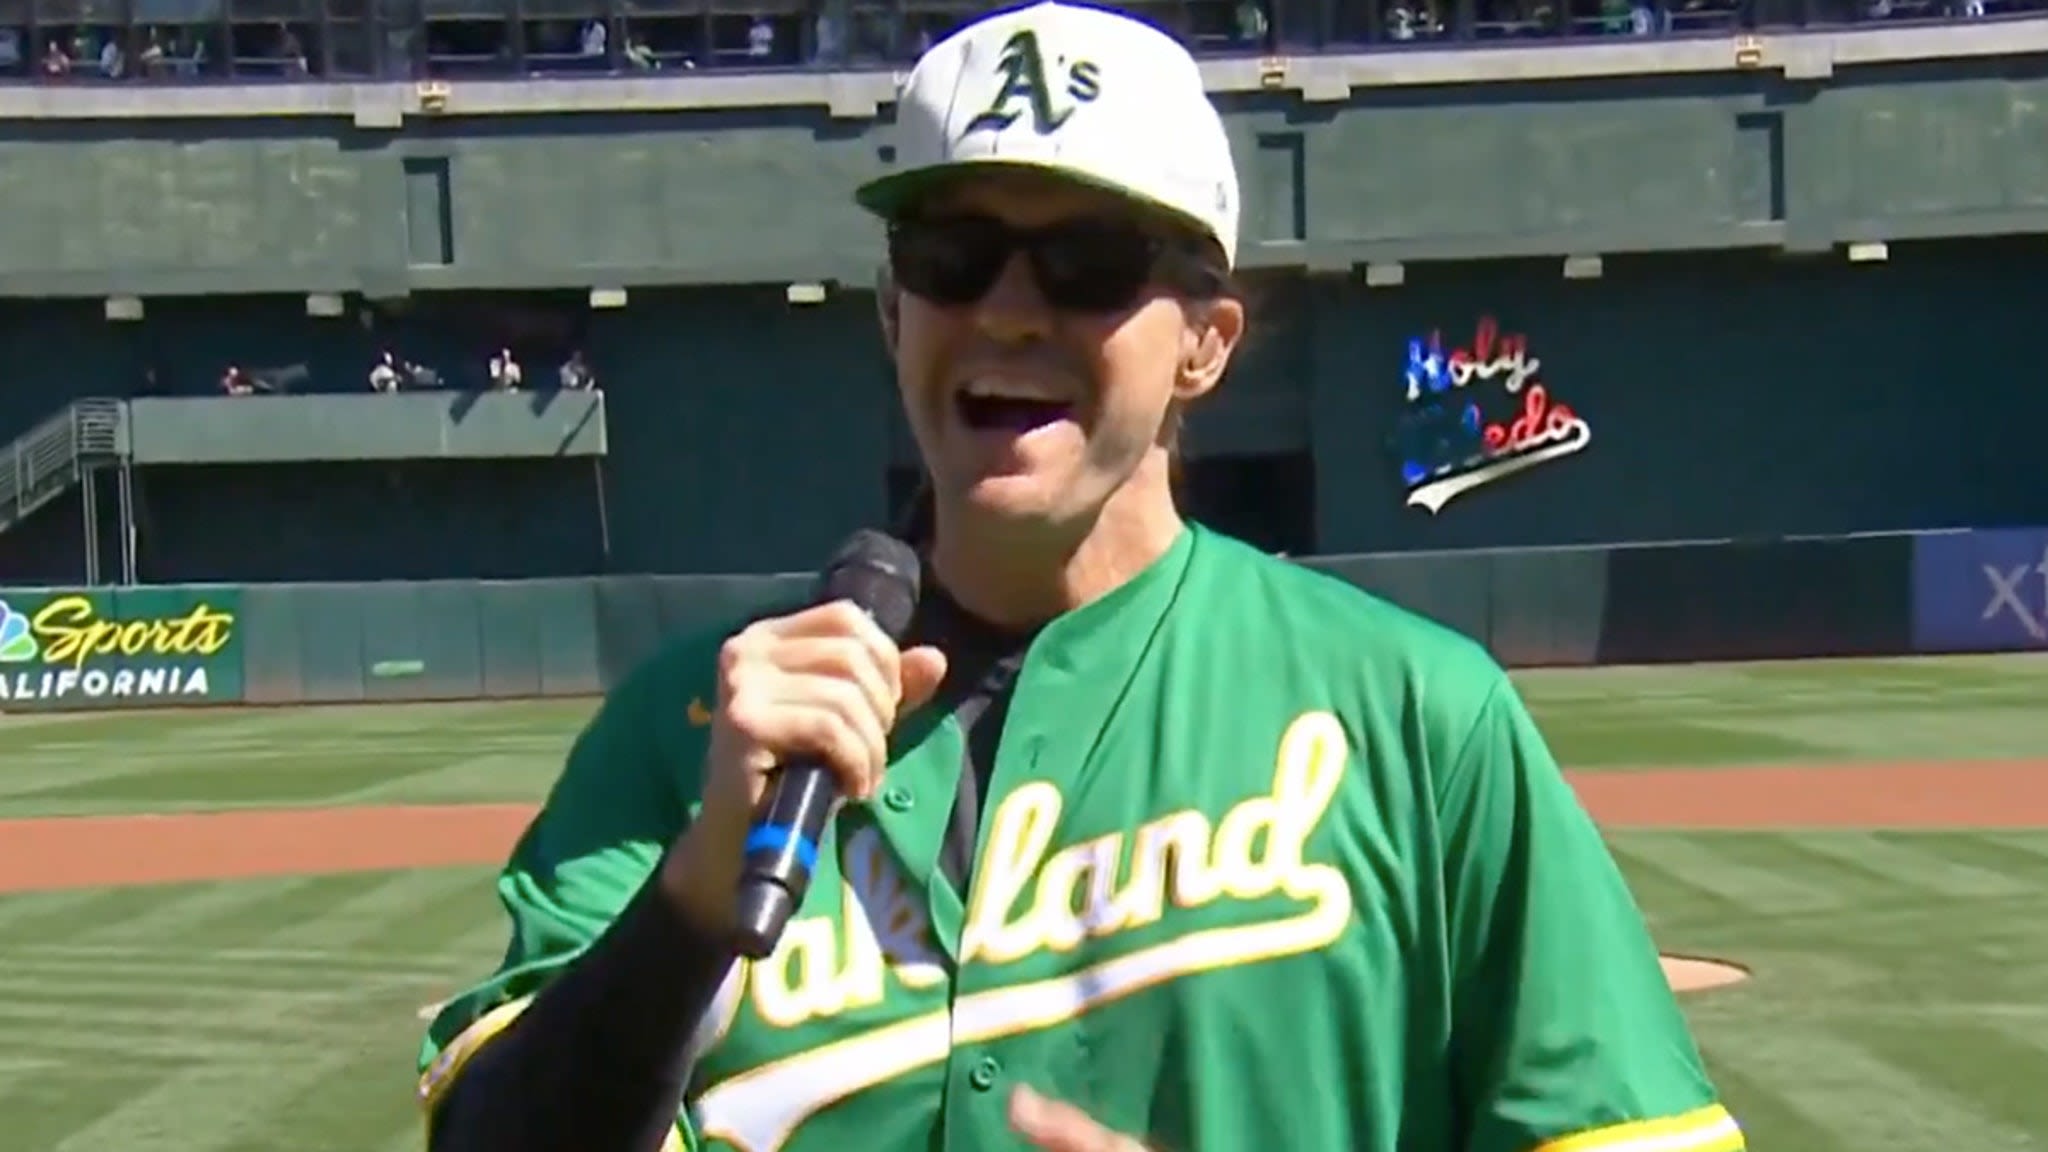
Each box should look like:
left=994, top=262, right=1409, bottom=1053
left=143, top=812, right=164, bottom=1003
left=0, top=760, right=2048, bottom=892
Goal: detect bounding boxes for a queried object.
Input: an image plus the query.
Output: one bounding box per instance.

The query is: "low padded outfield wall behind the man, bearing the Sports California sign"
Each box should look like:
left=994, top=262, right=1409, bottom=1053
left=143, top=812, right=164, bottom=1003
left=0, top=529, right=1982, bottom=711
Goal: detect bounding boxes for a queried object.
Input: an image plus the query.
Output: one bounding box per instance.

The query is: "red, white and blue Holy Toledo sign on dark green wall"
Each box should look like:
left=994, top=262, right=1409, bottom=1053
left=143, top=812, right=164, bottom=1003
left=1395, top=316, right=1593, bottom=515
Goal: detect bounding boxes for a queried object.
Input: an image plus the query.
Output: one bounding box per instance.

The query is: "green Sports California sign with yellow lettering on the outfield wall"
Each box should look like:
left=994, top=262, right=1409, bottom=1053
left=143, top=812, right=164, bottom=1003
left=0, top=588, right=242, bottom=711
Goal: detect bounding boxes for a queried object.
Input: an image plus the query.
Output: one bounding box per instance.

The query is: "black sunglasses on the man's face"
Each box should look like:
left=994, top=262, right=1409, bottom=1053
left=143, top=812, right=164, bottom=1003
left=889, top=215, right=1212, bottom=312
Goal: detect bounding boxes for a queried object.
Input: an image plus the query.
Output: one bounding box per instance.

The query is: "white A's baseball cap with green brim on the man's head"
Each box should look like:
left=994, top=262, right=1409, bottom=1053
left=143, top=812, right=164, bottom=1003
left=854, top=0, right=1237, bottom=264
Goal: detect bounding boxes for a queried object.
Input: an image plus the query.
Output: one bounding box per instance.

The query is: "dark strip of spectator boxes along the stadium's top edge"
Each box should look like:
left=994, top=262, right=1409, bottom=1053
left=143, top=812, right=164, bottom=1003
left=0, top=0, right=2048, bottom=86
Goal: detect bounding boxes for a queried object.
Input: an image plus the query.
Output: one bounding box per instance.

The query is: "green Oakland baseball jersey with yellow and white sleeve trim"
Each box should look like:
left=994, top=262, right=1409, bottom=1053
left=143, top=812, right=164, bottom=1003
left=420, top=527, right=1743, bottom=1152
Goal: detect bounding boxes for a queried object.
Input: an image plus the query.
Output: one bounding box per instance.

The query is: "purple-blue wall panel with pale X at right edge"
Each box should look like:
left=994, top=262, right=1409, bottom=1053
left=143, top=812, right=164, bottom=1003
left=1913, top=529, right=2048, bottom=652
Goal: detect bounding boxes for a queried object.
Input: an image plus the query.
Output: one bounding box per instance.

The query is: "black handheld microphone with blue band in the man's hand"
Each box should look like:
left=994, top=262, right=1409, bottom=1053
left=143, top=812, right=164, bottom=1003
left=733, top=529, right=920, bottom=959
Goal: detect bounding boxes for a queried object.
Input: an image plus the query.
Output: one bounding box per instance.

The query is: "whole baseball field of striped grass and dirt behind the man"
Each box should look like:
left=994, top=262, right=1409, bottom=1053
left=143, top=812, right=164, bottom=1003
left=0, top=658, right=2048, bottom=1152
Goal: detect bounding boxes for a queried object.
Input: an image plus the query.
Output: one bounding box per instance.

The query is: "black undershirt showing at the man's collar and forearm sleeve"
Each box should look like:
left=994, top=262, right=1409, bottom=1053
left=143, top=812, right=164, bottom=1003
left=430, top=588, right=1030, bottom=1152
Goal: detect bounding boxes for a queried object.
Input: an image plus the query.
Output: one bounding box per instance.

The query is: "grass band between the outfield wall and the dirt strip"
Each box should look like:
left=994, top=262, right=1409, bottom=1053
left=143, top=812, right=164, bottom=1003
left=0, top=660, right=2048, bottom=816
